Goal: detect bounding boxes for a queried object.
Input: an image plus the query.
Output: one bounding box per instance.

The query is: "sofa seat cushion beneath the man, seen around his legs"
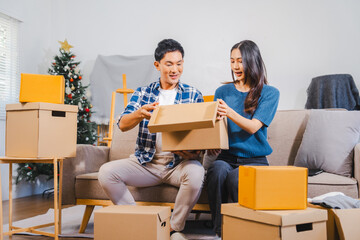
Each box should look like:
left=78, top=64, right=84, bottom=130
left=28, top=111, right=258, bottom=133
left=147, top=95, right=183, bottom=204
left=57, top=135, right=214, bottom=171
left=75, top=172, right=208, bottom=204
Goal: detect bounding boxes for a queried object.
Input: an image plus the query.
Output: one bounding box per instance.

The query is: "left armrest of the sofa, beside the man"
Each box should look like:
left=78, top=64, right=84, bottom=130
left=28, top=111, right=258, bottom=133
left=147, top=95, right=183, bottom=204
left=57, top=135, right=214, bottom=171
left=62, top=144, right=110, bottom=204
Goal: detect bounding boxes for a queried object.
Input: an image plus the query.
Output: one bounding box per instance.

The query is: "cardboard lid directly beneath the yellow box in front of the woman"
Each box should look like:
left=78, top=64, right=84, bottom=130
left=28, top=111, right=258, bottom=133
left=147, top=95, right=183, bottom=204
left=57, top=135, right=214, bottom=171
left=221, top=203, right=327, bottom=226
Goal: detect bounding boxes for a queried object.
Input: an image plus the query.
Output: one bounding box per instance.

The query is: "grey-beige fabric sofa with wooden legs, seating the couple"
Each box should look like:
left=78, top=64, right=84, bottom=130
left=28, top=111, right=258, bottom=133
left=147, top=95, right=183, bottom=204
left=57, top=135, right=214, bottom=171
left=62, top=110, right=360, bottom=231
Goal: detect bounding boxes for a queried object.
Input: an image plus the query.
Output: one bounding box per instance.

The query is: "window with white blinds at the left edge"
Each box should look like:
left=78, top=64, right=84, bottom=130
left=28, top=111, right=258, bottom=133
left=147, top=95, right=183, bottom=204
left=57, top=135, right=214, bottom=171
left=0, top=13, right=20, bottom=120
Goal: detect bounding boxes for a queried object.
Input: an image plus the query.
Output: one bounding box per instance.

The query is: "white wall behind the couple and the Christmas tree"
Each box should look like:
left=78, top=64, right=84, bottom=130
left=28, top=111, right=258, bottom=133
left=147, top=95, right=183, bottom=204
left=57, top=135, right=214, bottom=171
left=0, top=0, right=360, bottom=199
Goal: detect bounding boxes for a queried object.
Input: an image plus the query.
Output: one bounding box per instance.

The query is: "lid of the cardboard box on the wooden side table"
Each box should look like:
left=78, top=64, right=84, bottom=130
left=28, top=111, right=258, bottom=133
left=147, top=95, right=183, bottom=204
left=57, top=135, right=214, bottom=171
left=6, top=102, right=78, bottom=112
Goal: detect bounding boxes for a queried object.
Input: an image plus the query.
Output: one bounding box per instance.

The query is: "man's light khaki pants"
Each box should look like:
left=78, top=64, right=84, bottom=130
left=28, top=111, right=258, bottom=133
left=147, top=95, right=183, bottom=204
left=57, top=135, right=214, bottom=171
left=98, top=155, right=205, bottom=231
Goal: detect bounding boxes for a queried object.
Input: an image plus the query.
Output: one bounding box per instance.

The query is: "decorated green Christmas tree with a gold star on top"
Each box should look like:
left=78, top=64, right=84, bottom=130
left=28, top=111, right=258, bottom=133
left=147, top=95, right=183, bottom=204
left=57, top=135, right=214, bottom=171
left=16, top=40, right=97, bottom=183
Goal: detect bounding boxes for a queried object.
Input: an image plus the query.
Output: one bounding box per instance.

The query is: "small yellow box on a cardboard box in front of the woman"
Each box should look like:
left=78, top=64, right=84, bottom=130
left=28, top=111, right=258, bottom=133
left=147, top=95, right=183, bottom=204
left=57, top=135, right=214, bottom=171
left=239, top=166, right=308, bottom=210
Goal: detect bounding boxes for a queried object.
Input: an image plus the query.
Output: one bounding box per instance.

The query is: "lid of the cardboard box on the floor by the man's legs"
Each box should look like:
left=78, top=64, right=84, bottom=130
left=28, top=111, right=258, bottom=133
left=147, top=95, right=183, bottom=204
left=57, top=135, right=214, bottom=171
left=95, top=205, right=171, bottom=222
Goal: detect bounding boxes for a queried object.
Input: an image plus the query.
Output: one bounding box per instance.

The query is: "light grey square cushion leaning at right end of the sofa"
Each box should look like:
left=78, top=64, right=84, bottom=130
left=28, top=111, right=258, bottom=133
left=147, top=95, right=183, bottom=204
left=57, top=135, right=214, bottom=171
left=295, top=110, right=360, bottom=177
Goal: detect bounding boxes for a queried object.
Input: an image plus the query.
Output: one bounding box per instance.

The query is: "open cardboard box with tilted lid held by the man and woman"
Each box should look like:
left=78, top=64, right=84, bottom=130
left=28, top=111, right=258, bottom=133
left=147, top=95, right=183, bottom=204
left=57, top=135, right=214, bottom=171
left=148, top=102, right=229, bottom=151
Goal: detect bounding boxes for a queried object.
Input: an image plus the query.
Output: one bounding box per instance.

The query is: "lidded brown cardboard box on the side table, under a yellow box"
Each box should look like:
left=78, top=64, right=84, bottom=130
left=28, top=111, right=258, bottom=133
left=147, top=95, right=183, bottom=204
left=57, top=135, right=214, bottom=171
left=5, top=103, right=78, bottom=157
